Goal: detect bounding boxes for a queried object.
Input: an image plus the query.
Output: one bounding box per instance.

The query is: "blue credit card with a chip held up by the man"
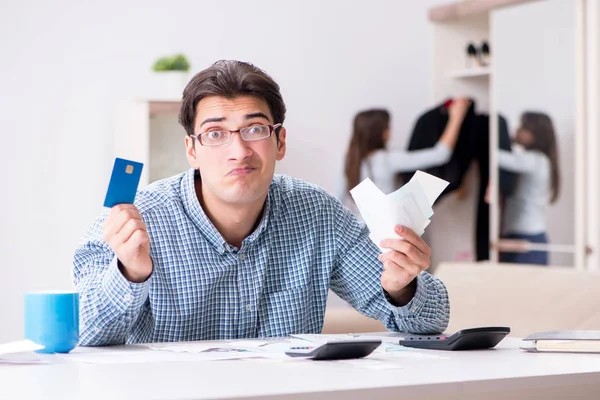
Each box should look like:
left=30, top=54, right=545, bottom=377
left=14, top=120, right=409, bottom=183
left=104, top=158, right=144, bottom=207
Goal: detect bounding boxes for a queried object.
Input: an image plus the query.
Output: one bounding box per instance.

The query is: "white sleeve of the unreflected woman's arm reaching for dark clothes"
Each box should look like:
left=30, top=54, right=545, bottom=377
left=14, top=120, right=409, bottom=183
left=388, top=142, right=452, bottom=172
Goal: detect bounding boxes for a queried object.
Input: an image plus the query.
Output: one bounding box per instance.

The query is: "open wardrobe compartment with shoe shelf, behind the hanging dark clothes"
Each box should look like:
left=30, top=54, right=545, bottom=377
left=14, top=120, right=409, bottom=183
left=426, top=7, right=493, bottom=265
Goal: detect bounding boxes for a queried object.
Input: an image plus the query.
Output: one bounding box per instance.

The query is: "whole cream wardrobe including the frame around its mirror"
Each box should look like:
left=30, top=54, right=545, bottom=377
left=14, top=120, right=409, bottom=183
left=427, top=0, right=600, bottom=270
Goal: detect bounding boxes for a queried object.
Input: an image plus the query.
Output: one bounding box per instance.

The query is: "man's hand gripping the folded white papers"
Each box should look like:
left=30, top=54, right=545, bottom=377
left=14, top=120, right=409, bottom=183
left=379, top=225, right=431, bottom=306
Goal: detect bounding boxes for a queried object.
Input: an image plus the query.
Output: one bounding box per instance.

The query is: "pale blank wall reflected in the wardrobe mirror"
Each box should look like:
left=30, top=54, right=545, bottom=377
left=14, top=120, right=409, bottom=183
left=492, top=0, right=576, bottom=266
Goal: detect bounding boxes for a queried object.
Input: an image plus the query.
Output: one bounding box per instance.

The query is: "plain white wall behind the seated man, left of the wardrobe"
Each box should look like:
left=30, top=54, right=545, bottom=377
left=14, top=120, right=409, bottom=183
left=0, top=0, right=443, bottom=341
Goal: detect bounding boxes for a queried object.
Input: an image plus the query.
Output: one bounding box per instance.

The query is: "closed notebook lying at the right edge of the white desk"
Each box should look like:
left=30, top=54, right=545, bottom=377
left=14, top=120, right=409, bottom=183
left=521, top=330, right=600, bottom=353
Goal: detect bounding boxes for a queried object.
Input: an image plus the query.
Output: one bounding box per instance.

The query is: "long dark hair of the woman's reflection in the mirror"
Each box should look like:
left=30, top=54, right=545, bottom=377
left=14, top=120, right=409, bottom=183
left=521, top=111, right=560, bottom=203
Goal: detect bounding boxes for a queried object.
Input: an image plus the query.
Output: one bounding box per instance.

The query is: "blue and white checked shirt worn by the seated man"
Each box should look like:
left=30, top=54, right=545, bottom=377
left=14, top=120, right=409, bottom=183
left=74, top=170, right=449, bottom=346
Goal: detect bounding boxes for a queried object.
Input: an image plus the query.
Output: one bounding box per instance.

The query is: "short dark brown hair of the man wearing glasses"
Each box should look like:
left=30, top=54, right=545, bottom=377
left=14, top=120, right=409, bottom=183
left=179, top=60, right=285, bottom=139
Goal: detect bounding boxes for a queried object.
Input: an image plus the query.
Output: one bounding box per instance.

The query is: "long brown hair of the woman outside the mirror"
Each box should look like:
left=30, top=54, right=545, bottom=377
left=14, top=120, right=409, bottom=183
left=344, top=109, right=390, bottom=190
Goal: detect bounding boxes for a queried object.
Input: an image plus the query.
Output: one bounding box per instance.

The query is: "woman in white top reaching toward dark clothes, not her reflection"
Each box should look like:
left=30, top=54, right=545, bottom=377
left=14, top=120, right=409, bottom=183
left=338, top=98, right=471, bottom=214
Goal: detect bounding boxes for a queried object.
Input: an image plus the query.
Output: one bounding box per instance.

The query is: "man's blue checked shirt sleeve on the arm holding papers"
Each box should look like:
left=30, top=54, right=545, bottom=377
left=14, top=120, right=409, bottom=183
left=330, top=202, right=450, bottom=334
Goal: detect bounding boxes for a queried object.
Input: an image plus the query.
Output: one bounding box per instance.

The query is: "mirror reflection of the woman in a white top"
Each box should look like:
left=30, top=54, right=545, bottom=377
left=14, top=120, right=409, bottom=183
left=498, top=112, right=560, bottom=265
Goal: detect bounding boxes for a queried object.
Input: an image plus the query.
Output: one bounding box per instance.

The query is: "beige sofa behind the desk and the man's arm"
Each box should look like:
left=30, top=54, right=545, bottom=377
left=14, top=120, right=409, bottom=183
left=323, top=263, right=600, bottom=337
